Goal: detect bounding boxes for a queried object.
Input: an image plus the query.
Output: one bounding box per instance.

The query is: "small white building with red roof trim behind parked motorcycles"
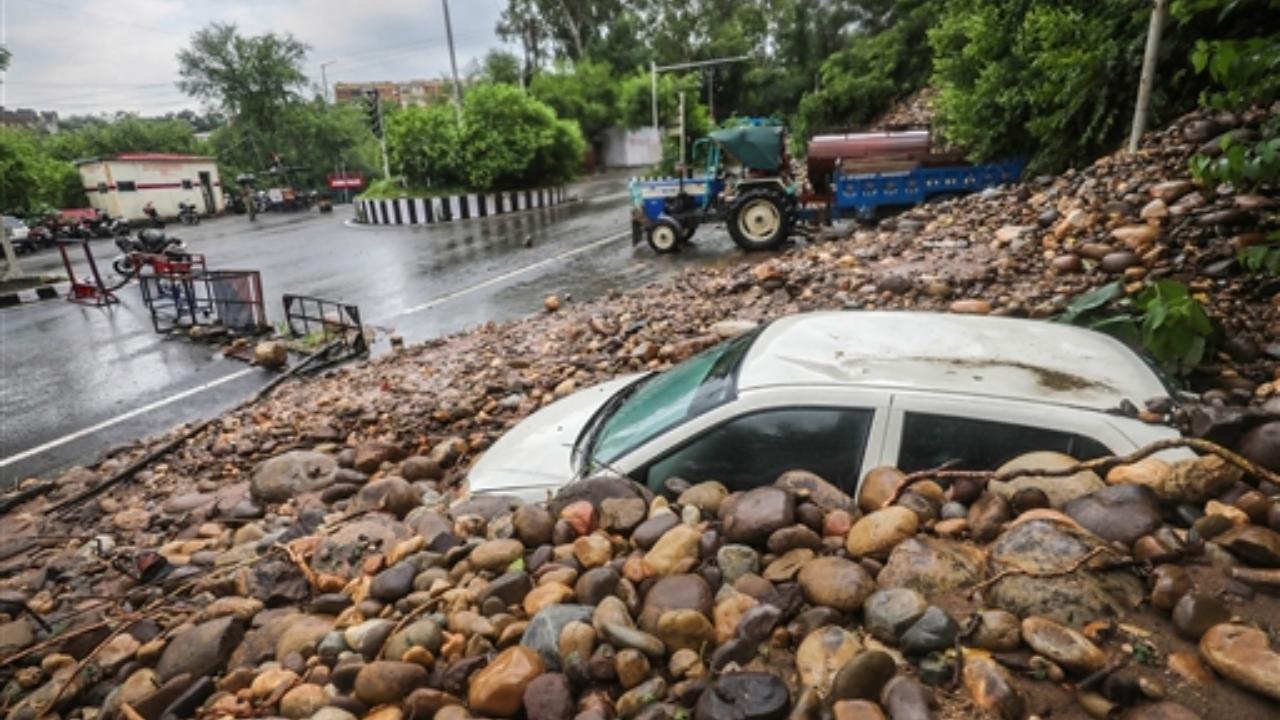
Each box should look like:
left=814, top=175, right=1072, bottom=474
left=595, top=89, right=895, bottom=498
left=76, top=152, right=225, bottom=220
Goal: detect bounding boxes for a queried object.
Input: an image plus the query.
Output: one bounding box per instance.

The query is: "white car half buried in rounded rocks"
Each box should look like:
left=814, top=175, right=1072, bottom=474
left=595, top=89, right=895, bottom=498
left=467, top=311, right=1178, bottom=501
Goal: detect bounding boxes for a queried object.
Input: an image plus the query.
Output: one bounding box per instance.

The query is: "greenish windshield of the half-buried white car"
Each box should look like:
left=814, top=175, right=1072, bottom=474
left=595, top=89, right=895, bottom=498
left=590, top=332, right=756, bottom=465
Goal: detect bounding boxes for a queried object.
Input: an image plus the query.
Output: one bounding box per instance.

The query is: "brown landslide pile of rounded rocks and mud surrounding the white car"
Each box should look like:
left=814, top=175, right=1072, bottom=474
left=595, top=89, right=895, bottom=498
left=0, top=107, right=1280, bottom=720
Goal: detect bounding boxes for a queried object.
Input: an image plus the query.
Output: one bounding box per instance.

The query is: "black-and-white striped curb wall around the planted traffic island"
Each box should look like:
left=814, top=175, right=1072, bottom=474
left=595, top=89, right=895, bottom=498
left=356, top=187, right=570, bottom=225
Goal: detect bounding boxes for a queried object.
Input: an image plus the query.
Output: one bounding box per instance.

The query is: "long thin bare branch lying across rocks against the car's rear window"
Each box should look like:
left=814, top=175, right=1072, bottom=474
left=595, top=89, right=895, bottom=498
left=883, top=430, right=1280, bottom=507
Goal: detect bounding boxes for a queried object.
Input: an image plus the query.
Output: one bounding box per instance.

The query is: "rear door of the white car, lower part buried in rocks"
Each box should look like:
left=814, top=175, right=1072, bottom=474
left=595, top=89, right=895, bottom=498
left=881, top=392, right=1135, bottom=473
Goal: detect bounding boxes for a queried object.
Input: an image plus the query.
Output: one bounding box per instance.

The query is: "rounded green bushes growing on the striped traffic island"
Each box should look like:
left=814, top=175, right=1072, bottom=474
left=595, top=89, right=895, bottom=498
left=387, top=85, right=586, bottom=190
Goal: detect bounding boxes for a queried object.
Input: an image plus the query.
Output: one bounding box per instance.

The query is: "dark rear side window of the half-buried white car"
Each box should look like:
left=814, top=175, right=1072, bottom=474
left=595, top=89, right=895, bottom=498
left=897, top=413, right=1111, bottom=473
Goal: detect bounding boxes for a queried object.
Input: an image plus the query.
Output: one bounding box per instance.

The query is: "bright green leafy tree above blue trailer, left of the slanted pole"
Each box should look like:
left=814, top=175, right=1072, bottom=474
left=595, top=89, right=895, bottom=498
left=929, top=0, right=1149, bottom=170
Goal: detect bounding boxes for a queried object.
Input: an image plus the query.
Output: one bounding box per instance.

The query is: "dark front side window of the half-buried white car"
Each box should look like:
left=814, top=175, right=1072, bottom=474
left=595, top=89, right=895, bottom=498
left=639, top=407, right=876, bottom=492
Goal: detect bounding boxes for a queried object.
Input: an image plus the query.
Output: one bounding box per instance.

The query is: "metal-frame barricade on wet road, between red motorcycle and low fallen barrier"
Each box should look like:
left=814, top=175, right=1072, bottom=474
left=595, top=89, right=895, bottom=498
left=138, top=264, right=268, bottom=333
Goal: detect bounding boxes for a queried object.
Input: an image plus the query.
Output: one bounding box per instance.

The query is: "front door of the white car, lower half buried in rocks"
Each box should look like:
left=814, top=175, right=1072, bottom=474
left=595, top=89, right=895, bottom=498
left=617, top=387, right=888, bottom=493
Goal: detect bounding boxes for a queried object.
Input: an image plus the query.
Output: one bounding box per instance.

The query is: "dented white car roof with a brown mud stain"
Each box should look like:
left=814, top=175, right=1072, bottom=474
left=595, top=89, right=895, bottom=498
left=737, top=311, right=1169, bottom=410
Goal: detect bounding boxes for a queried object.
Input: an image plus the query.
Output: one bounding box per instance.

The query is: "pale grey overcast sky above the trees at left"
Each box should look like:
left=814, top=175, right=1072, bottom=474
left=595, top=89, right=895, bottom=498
left=0, top=0, right=513, bottom=115
